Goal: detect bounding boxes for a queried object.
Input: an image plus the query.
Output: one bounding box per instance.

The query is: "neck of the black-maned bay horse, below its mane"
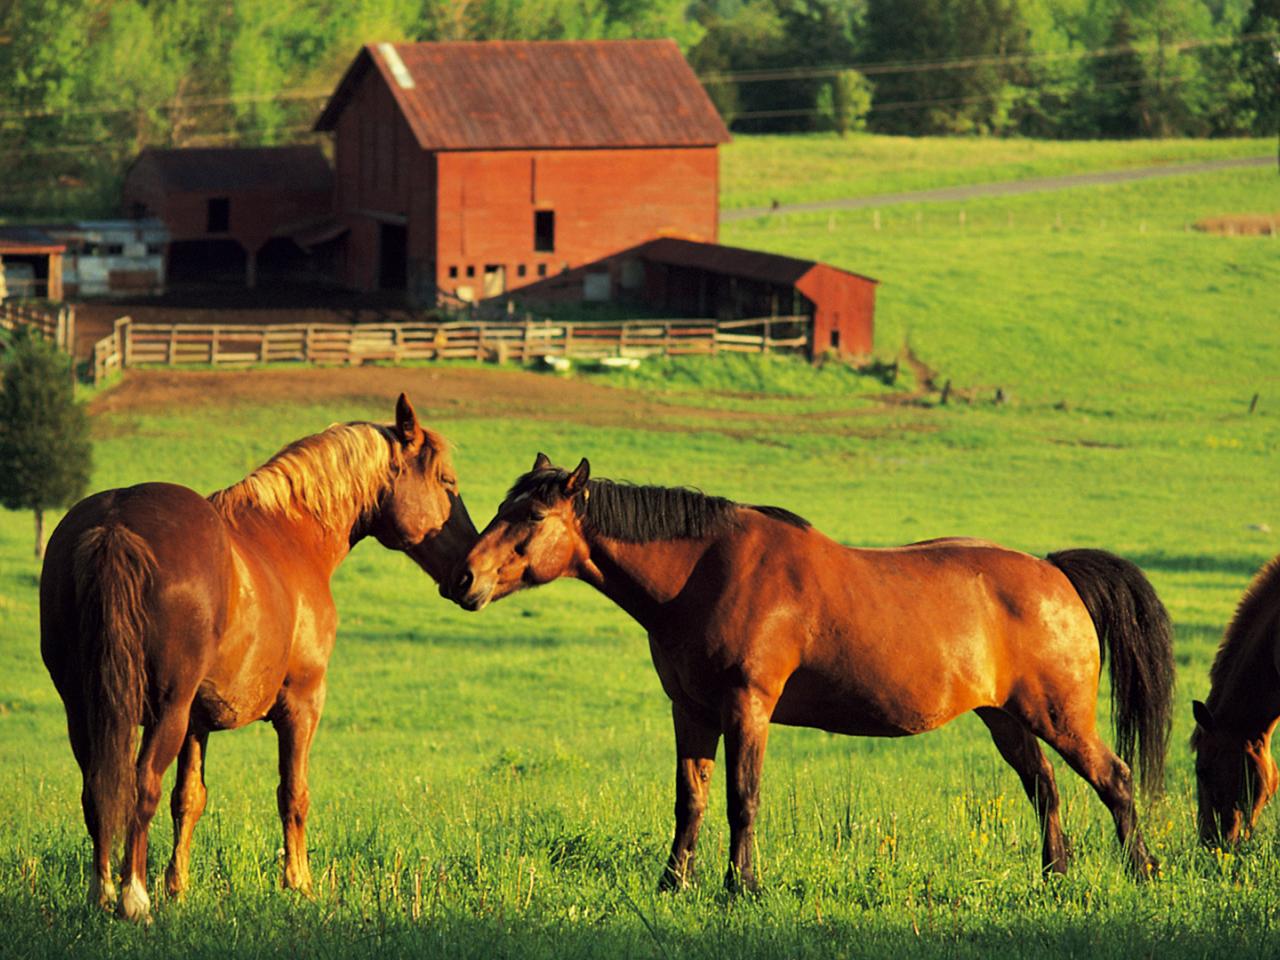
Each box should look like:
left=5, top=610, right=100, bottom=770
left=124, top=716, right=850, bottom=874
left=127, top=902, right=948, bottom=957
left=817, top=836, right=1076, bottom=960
left=579, top=535, right=712, bottom=630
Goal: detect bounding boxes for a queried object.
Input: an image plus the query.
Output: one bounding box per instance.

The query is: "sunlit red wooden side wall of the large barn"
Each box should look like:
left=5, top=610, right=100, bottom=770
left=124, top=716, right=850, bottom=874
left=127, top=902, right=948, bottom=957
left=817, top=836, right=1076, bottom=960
left=436, top=147, right=718, bottom=294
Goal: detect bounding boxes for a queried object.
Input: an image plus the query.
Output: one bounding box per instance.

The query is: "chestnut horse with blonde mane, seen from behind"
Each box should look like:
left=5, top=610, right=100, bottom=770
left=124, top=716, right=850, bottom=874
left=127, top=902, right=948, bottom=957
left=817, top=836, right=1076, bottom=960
left=40, top=394, right=476, bottom=920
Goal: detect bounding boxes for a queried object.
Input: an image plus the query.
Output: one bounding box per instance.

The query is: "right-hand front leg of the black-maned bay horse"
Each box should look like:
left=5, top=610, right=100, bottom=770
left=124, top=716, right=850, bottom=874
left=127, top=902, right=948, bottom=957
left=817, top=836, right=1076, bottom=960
left=721, top=689, right=777, bottom=892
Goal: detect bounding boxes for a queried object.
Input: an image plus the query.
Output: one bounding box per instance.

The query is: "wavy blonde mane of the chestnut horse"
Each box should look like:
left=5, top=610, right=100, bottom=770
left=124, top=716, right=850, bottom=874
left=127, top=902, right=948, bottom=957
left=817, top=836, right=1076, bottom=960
left=209, top=422, right=402, bottom=529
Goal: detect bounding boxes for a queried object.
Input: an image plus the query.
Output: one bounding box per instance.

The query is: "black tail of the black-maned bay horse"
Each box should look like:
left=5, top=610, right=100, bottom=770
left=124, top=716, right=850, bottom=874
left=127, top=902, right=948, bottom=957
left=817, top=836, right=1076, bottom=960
left=1046, top=550, right=1174, bottom=794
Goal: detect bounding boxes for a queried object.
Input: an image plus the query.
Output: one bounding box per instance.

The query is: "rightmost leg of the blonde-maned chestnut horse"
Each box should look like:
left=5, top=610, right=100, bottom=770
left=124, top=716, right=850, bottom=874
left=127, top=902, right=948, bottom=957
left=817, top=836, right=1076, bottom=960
left=271, top=684, right=324, bottom=896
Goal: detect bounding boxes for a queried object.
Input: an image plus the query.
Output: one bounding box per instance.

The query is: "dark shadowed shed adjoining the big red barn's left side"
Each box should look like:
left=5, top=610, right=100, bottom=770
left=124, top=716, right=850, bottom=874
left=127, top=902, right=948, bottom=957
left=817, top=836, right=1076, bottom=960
left=124, top=146, right=333, bottom=287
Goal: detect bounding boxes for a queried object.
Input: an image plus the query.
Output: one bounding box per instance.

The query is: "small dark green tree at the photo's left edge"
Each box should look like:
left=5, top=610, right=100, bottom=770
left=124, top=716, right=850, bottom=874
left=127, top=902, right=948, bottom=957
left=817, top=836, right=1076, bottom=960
left=0, top=332, right=92, bottom=558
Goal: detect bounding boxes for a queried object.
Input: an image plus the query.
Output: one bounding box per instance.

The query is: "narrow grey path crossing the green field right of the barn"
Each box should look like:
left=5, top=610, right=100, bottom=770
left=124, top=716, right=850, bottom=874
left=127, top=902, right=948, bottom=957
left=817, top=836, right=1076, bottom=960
left=721, top=156, right=1276, bottom=223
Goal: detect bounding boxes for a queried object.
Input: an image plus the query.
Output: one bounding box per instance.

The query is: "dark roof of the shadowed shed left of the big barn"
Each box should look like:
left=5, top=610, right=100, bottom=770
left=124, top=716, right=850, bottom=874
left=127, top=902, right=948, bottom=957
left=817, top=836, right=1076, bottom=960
left=126, top=146, right=333, bottom=193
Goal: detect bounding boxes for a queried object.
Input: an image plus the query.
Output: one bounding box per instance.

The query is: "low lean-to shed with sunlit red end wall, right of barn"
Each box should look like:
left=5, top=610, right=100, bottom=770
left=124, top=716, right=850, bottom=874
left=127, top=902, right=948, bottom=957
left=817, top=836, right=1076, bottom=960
left=622, top=237, right=878, bottom=356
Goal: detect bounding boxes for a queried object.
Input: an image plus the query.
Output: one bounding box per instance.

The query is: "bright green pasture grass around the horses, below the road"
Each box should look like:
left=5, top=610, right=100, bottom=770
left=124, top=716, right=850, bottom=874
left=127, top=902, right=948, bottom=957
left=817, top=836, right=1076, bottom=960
left=0, top=141, right=1280, bottom=959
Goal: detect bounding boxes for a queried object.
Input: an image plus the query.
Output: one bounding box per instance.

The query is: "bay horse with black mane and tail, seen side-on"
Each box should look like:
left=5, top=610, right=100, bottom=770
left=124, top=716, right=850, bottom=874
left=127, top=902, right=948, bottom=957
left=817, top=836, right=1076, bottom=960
left=445, top=454, right=1174, bottom=890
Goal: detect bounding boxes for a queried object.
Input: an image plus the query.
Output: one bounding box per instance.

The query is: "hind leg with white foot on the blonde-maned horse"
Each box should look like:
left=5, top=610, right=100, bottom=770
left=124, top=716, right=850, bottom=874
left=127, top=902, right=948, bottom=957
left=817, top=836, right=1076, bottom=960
left=118, top=699, right=191, bottom=922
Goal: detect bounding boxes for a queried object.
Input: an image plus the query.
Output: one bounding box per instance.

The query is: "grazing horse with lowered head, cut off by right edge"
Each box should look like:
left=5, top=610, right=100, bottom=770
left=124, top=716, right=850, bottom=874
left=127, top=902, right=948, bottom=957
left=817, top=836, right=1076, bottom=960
left=1192, top=557, right=1280, bottom=844
